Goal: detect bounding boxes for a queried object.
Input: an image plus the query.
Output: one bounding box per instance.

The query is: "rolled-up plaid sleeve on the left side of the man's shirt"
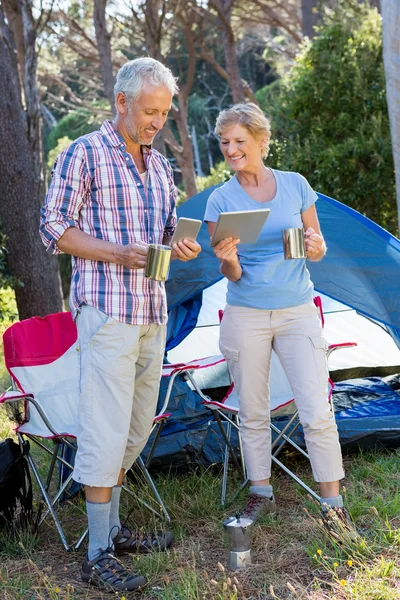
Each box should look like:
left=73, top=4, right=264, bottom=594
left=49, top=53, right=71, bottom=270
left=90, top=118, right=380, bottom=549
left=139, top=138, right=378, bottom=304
left=40, top=142, right=90, bottom=254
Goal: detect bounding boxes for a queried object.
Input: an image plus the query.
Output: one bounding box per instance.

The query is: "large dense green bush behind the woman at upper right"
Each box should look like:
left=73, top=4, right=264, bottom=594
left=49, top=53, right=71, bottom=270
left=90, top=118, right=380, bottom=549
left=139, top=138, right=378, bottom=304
left=257, top=0, right=397, bottom=233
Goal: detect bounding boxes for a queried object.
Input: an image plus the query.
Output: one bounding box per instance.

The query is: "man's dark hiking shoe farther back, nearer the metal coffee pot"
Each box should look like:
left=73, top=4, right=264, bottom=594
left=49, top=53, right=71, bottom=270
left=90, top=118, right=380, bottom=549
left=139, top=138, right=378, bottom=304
left=113, top=527, right=173, bottom=556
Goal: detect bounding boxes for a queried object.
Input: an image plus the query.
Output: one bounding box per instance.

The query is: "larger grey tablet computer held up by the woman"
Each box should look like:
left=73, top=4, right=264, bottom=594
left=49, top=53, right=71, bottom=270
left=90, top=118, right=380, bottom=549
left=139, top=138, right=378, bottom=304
left=210, top=208, right=271, bottom=246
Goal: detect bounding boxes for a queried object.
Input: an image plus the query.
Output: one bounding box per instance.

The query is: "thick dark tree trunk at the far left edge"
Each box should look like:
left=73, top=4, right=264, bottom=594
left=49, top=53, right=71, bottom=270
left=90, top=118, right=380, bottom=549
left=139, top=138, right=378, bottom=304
left=0, top=5, right=62, bottom=319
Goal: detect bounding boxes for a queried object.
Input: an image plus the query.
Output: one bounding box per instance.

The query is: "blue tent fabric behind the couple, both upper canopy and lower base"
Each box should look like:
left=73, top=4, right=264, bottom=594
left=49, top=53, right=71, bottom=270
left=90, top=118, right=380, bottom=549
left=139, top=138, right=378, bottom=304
left=144, top=188, right=400, bottom=467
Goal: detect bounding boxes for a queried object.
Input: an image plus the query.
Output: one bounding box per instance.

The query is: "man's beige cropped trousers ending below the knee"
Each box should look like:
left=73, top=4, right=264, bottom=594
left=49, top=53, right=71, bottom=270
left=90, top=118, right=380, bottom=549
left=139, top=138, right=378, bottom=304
left=73, top=306, right=166, bottom=487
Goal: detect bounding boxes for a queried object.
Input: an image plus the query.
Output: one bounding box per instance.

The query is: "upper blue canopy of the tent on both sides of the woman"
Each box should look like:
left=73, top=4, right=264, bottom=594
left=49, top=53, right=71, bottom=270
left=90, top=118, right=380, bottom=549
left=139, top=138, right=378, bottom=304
left=167, top=188, right=400, bottom=350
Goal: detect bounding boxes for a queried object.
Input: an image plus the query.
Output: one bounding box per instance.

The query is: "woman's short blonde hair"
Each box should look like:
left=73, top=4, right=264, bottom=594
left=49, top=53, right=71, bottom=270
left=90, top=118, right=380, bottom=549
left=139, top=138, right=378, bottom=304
left=214, top=102, right=271, bottom=158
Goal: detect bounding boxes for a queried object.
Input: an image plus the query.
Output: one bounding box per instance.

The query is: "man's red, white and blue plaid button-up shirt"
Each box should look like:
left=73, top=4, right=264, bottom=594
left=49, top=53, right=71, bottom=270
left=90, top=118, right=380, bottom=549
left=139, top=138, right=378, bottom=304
left=40, top=121, right=176, bottom=325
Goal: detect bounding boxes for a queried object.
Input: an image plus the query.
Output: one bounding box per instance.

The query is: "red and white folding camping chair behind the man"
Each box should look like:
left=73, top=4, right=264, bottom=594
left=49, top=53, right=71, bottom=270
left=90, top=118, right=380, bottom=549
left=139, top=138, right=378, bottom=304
left=0, top=312, right=170, bottom=551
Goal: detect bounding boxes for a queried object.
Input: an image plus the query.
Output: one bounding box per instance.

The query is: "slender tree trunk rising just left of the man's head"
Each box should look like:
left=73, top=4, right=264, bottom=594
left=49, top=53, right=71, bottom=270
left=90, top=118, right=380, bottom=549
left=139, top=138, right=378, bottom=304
left=93, top=0, right=115, bottom=113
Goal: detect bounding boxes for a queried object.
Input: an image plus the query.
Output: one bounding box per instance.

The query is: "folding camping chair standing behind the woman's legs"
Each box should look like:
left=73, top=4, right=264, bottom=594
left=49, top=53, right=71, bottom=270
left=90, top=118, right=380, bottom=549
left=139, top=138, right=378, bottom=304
left=200, top=296, right=357, bottom=506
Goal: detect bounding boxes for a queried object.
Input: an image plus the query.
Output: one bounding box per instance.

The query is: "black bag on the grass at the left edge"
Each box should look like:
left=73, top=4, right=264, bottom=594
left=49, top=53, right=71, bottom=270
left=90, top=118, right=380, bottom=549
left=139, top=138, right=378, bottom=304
left=0, top=438, right=32, bottom=528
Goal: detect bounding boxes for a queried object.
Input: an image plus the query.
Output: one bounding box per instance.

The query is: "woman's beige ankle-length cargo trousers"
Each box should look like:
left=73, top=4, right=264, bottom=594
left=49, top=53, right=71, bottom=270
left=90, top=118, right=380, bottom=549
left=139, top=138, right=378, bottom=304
left=220, top=302, right=344, bottom=482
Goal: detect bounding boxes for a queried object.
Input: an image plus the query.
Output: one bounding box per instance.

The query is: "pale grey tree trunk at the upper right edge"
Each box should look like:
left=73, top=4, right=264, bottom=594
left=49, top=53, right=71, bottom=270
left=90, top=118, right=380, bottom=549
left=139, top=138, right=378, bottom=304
left=382, top=0, right=400, bottom=235
